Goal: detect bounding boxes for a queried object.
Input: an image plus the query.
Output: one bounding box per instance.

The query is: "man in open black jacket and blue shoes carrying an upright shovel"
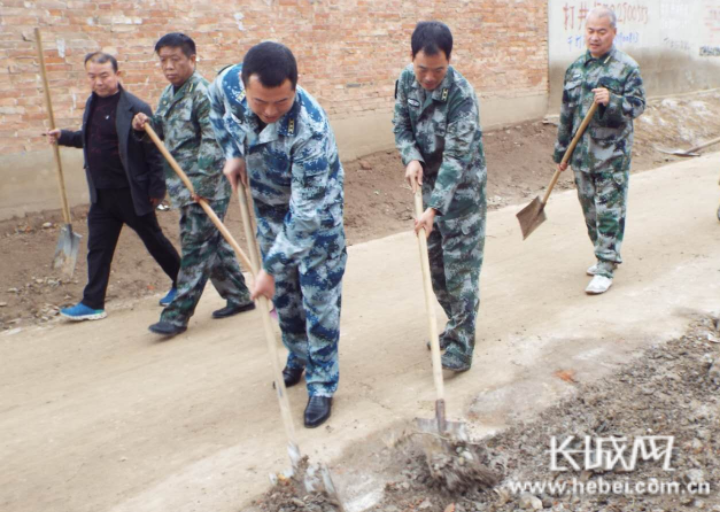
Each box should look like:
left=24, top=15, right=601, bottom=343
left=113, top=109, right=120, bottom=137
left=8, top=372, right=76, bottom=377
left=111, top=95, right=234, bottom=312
left=47, top=52, right=180, bottom=320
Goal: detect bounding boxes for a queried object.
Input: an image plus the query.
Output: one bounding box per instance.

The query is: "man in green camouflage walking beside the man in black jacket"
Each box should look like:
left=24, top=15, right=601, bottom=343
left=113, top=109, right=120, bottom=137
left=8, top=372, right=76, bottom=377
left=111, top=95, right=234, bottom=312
left=133, top=33, right=255, bottom=336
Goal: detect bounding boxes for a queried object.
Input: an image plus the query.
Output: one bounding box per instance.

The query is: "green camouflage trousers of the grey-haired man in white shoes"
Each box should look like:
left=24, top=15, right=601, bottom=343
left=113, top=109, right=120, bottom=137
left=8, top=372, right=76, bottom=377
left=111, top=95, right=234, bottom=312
left=574, top=164, right=630, bottom=278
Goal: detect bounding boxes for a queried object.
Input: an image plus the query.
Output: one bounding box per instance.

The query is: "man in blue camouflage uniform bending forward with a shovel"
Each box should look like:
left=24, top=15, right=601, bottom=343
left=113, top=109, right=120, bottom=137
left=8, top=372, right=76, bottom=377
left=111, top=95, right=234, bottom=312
left=209, top=42, right=347, bottom=427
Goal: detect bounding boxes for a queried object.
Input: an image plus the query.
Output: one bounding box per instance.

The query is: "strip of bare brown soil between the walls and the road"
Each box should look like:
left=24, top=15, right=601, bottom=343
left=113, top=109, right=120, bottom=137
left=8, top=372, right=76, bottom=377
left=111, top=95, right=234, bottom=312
left=0, top=92, right=720, bottom=330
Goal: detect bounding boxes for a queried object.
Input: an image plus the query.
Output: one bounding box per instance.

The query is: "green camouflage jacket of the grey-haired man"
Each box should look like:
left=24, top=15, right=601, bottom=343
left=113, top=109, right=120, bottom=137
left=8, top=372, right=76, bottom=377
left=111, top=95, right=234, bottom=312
left=553, top=47, right=645, bottom=172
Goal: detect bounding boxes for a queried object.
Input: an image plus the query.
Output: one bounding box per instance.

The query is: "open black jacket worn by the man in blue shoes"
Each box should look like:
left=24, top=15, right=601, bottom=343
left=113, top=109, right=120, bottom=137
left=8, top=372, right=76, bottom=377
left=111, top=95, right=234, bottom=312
left=58, top=87, right=165, bottom=215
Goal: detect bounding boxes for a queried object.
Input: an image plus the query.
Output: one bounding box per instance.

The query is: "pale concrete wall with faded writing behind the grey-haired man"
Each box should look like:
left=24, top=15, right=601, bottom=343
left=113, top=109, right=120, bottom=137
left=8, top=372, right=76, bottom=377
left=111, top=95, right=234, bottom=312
left=548, top=0, right=720, bottom=112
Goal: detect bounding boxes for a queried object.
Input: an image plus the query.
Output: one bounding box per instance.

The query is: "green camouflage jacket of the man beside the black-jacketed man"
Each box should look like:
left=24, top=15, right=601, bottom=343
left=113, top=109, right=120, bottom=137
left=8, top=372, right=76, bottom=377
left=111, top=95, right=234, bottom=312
left=152, top=71, right=231, bottom=207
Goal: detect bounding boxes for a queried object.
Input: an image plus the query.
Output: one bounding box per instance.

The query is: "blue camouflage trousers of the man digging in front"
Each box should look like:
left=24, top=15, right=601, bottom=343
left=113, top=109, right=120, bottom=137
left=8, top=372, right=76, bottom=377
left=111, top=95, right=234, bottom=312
left=260, top=226, right=347, bottom=396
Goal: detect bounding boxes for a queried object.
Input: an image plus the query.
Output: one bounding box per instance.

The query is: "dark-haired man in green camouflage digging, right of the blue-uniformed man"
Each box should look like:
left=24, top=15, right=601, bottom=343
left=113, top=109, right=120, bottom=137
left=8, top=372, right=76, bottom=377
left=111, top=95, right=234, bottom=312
left=393, top=22, right=487, bottom=372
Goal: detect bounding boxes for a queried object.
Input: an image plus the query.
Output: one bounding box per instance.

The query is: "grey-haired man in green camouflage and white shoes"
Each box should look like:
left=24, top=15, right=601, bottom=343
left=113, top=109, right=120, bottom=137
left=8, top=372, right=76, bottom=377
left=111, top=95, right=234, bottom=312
left=553, top=7, right=645, bottom=294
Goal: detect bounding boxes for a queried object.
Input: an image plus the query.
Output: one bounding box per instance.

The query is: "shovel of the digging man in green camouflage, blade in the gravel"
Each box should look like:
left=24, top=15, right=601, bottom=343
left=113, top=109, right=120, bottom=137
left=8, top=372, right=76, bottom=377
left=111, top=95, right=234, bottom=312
left=415, top=191, right=467, bottom=444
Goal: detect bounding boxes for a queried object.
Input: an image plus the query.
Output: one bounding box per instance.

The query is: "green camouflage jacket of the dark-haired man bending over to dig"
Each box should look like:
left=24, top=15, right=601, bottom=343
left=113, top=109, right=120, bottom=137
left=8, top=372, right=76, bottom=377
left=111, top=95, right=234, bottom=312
left=393, top=65, right=487, bottom=219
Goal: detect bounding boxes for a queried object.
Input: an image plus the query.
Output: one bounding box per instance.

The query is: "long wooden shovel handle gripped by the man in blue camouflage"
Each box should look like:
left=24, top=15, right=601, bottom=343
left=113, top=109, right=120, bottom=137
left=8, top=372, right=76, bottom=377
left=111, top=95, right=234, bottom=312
left=238, top=182, right=300, bottom=456
